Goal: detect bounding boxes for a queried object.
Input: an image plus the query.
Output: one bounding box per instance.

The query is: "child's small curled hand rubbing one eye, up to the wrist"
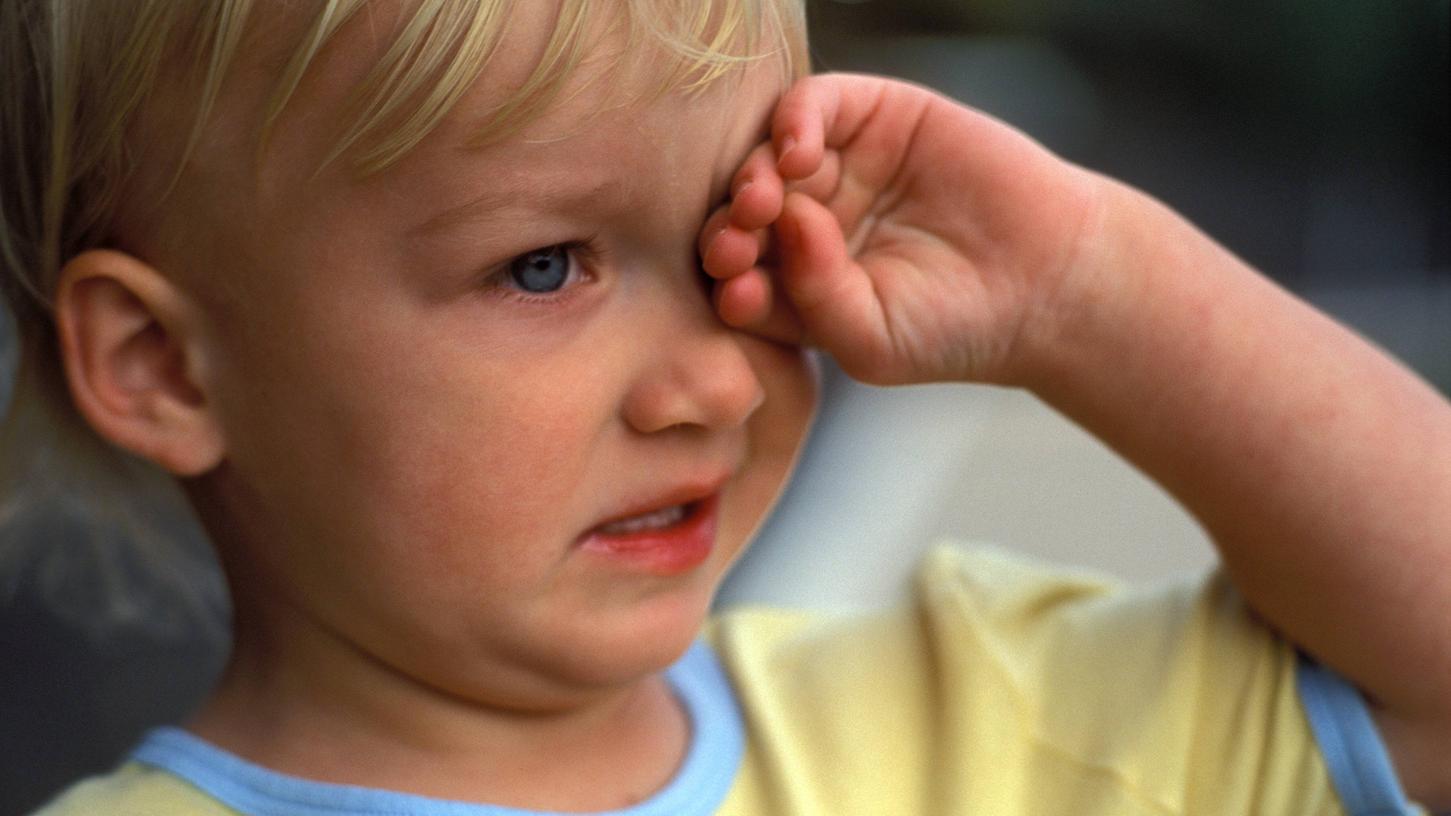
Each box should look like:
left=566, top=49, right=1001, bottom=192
left=701, top=74, right=1101, bottom=383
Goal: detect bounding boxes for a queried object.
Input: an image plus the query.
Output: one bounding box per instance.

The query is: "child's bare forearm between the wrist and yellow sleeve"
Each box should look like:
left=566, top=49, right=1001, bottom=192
left=1027, top=176, right=1451, bottom=722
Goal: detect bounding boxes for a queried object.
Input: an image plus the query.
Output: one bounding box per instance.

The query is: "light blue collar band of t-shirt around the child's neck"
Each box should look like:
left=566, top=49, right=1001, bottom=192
left=132, top=642, right=746, bottom=816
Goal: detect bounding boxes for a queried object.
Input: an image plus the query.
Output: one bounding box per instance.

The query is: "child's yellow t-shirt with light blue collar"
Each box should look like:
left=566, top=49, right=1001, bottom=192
left=34, top=547, right=1409, bottom=816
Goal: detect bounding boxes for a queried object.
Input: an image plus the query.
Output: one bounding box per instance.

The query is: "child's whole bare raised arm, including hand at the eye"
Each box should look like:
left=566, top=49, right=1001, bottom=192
left=701, top=76, right=1451, bottom=810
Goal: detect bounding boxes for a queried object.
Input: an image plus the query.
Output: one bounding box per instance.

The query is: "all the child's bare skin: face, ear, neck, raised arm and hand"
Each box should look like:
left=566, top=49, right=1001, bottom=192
left=57, top=4, right=1451, bottom=810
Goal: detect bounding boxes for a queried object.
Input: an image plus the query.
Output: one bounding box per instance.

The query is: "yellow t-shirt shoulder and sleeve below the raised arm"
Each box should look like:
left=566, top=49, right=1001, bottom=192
left=714, top=546, right=1335, bottom=813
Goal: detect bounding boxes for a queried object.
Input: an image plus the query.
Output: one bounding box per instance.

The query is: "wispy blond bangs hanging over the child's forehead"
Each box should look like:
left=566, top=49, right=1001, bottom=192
left=263, top=0, right=807, bottom=176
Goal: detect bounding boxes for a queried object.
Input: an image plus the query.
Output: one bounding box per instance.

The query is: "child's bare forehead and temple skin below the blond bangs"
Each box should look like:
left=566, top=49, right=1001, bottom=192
left=138, top=0, right=785, bottom=304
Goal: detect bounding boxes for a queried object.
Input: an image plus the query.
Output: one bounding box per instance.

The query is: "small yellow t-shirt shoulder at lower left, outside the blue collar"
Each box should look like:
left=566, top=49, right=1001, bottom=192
left=32, top=762, right=237, bottom=816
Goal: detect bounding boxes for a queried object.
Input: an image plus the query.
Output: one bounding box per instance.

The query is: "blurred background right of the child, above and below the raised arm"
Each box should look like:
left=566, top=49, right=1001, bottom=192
left=721, top=0, right=1451, bottom=607
